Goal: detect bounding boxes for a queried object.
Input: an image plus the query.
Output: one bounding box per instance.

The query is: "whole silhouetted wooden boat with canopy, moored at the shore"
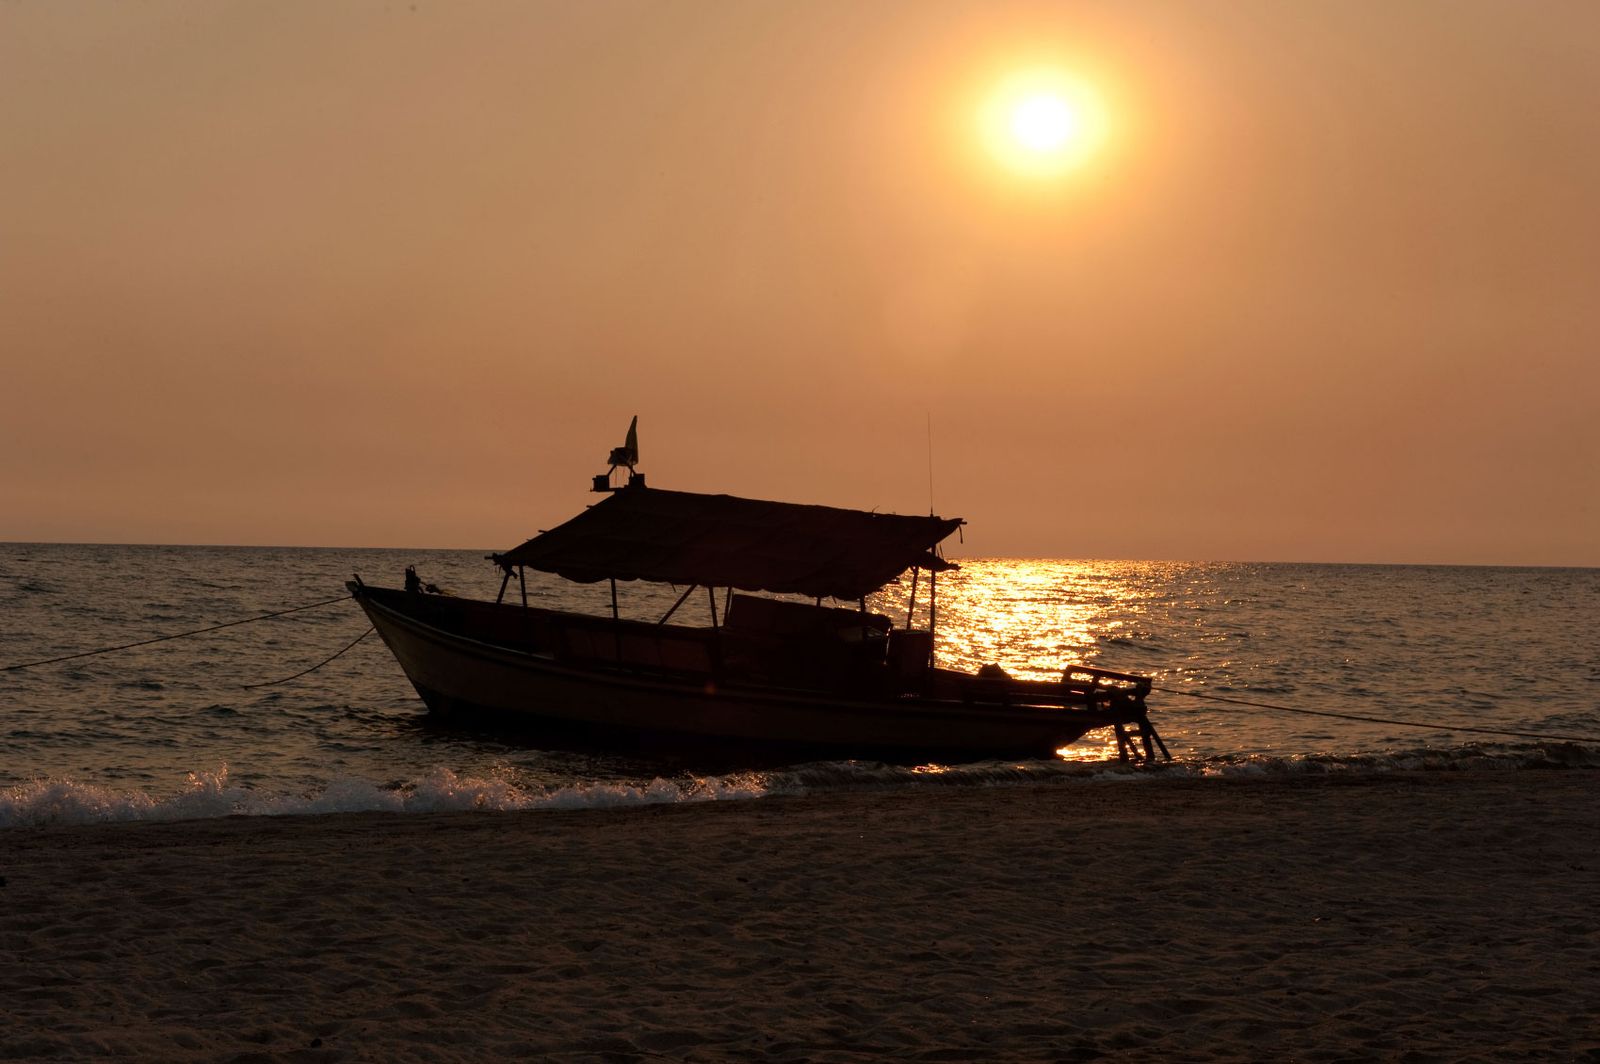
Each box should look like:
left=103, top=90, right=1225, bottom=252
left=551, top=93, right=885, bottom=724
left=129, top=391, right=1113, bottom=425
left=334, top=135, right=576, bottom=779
left=347, top=418, right=1170, bottom=762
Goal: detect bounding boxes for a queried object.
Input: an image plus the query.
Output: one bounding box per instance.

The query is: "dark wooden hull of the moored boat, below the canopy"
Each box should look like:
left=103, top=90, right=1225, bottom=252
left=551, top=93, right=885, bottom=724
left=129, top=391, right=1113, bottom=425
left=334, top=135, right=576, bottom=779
left=349, top=582, right=1142, bottom=760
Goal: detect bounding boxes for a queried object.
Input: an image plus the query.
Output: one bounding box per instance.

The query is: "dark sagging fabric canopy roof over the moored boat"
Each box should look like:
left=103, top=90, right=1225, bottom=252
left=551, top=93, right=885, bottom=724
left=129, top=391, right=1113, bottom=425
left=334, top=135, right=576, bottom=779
left=491, top=486, right=962, bottom=598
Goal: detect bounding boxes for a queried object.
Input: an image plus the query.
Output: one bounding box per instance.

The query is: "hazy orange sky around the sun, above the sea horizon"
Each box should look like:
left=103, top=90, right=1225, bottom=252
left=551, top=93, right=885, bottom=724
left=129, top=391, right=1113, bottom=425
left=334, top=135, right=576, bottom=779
left=0, top=0, right=1600, bottom=565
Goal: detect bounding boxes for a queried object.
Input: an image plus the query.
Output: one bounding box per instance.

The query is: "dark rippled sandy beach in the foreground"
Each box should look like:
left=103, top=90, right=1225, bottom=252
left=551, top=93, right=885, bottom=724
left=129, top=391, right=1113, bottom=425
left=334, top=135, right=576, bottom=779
left=0, top=771, right=1600, bottom=1061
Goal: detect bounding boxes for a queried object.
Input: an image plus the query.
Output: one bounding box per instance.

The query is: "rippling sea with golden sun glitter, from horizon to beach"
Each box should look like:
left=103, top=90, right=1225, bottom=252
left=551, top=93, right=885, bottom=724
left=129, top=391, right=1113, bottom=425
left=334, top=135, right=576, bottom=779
left=0, top=544, right=1600, bottom=829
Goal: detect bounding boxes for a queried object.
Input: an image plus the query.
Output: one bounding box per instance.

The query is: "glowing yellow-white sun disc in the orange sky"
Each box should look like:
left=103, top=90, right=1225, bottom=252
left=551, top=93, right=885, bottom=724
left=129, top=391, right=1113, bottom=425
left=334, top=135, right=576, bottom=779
left=979, top=67, right=1106, bottom=178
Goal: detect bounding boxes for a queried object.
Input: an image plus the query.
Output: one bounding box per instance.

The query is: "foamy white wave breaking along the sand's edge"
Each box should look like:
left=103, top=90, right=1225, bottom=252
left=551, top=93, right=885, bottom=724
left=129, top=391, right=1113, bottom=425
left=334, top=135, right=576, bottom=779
left=0, top=742, right=1600, bottom=829
